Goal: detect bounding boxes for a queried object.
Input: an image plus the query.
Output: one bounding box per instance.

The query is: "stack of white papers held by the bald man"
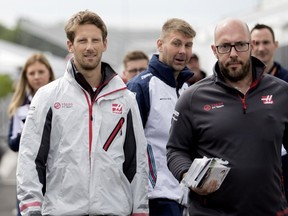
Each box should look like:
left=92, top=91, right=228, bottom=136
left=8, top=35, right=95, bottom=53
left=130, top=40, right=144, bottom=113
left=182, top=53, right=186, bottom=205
left=181, top=157, right=230, bottom=189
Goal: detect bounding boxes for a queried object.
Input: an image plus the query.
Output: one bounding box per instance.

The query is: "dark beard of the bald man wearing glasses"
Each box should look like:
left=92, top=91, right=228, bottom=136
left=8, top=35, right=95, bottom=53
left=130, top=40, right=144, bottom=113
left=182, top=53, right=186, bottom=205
left=219, top=60, right=251, bottom=82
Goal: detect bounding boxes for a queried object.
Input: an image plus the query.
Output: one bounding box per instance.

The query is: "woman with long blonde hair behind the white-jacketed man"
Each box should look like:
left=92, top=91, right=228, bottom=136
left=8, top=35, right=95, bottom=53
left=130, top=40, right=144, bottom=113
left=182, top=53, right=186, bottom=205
left=8, top=53, right=55, bottom=216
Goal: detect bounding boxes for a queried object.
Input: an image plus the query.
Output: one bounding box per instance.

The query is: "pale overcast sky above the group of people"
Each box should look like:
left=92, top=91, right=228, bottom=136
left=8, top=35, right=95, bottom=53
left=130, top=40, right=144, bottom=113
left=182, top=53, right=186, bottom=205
left=0, top=0, right=261, bottom=28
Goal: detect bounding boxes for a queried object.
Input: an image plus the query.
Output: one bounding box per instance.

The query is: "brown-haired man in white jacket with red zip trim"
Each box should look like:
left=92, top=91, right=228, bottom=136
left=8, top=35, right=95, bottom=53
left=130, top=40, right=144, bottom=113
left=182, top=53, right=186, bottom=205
left=17, top=10, right=149, bottom=216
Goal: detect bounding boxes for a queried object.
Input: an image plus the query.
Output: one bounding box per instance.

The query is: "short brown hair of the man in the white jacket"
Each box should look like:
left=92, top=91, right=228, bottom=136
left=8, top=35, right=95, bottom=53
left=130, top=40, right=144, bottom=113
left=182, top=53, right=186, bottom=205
left=65, top=10, right=108, bottom=43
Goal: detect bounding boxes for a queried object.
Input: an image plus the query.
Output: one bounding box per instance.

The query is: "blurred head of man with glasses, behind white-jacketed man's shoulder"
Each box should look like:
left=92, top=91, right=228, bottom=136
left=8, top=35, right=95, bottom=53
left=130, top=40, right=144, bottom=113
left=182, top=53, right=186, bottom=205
left=122, top=50, right=149, bottom=83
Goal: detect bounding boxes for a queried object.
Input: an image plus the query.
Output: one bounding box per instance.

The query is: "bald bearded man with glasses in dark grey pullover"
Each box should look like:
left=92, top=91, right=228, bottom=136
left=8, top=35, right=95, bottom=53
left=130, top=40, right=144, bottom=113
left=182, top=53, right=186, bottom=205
left=167, top=18, right=288, bottom=216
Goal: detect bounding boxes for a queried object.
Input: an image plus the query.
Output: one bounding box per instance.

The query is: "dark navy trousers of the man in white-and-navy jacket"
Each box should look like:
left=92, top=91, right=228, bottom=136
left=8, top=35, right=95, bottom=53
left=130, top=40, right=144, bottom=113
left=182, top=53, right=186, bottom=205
left=149, top=198, right=183, bottom=216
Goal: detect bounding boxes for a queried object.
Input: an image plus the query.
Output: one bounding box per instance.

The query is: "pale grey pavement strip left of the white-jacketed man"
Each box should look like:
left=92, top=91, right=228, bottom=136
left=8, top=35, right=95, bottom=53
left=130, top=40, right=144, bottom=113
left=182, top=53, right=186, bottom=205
left=0, top=150, right=17, bottom=216
